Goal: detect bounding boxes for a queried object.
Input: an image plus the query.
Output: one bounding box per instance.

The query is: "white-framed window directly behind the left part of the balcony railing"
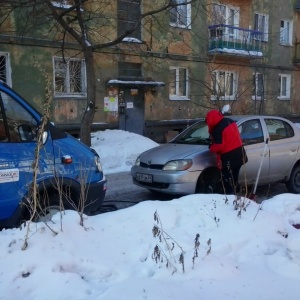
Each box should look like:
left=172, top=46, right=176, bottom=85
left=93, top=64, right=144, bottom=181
left=210, top=3, right=240, bottom=38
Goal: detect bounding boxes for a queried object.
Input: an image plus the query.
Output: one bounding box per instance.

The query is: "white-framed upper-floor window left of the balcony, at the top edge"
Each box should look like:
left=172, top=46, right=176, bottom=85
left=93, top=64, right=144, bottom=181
left=170, top=0, right=191, bottom=29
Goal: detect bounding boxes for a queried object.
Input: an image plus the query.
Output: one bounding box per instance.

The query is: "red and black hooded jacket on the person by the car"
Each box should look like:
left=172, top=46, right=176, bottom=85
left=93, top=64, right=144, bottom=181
left=206, top=110, right=247, bottom=165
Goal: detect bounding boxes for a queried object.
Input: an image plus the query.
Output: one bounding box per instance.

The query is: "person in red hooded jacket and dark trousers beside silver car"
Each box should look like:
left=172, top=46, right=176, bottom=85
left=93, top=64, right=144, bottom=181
left=205, top=109, right=248, bottom=194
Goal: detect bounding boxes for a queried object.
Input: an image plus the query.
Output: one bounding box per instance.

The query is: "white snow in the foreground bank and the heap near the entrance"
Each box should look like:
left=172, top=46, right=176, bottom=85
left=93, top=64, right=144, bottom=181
left=0, top=130, right=300, bottom=300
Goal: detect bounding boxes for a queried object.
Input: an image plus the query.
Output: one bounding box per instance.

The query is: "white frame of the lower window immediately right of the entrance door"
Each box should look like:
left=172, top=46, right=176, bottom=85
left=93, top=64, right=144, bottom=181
left=169, top=67, right=190, bottom=100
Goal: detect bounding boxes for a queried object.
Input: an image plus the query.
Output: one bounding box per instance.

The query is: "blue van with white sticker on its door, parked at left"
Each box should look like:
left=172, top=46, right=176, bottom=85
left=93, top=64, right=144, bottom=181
left=0, top=81, right=106, bottom=228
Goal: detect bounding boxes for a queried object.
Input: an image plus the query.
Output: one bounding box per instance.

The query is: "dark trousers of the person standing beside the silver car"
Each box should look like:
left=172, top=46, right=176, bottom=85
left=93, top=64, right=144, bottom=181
left=221, top=163, right=241, bottom=195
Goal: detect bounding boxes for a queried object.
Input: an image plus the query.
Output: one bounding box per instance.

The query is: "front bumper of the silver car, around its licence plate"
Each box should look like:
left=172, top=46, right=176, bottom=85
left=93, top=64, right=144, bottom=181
left=131, top=166, right=201, bottom=195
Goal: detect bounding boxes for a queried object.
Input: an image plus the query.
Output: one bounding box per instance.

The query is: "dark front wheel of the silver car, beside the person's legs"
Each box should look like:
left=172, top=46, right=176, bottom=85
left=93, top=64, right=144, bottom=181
left=195, top=168, right=221, bottom=194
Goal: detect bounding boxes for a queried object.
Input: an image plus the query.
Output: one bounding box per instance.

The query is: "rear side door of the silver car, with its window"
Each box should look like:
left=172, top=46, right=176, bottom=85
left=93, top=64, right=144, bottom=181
left=265, top=117, right=299, bottom=182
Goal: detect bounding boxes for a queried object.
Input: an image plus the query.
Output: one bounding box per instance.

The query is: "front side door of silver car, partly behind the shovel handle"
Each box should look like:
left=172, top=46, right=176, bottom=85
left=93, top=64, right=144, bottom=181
left=238, top=118, right=270, bottom=184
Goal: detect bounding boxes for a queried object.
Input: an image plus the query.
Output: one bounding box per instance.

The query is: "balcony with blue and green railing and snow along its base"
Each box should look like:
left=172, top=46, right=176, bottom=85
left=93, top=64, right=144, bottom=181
left=208, top=24, right=265, bottom=58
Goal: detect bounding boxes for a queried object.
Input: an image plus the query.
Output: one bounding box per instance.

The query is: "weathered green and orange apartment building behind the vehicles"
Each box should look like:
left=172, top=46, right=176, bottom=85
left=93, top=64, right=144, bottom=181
left=0, top=0, right=300, bottom=142
